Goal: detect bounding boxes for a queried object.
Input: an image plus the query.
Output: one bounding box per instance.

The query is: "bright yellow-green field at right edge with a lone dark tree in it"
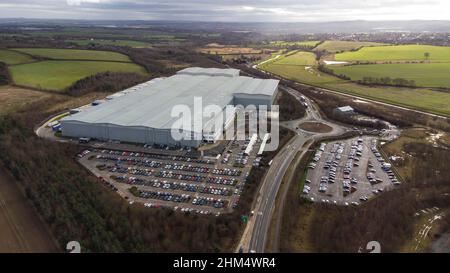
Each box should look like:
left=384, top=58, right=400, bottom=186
left=335, top=45, right=450, bottom=62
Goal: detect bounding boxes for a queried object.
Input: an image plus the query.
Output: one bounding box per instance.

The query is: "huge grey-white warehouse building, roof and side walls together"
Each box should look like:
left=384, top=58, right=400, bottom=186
left=61, top=67, right=279, bottom=147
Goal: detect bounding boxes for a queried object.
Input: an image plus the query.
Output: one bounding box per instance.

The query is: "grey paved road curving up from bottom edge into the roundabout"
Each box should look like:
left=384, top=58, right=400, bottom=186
left=239, top=86, right=350, bottom=253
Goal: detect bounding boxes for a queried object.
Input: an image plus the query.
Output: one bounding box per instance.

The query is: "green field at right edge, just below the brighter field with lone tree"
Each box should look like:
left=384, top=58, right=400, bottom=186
left=332, top=63, right=450, bottom=87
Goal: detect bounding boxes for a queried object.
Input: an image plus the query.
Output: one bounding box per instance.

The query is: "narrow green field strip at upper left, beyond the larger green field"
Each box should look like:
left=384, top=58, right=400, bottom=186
left=14, top=48, right=131, bottom=62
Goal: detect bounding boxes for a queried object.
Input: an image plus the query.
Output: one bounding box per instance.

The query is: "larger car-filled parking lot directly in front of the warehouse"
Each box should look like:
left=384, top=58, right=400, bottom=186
left=78, top=136, right=261, bottom=215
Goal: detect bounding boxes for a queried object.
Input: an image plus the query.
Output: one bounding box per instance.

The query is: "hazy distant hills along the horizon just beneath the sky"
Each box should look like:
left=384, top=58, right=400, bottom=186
left=0, top=18, right=450, bottom=34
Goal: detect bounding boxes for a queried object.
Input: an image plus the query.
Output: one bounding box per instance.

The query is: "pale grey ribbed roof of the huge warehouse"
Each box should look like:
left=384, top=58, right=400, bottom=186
left=61, top=67, right=278, bottom=132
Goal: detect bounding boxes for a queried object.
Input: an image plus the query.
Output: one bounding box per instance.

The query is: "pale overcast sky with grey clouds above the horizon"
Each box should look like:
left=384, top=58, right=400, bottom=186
left=0, top=0, right=450, bottom=22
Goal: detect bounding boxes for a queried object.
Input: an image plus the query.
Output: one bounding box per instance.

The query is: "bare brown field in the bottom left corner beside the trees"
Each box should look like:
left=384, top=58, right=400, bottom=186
left=0, top=168, right=60, bottom=252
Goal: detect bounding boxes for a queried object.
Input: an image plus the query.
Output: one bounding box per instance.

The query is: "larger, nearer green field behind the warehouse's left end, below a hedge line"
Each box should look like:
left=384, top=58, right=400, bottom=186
left=9, top=61, right=146, bottom=90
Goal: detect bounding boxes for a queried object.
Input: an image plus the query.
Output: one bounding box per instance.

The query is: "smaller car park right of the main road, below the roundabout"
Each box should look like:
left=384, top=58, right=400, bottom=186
left=302, top=136, right=400, bottom=206
